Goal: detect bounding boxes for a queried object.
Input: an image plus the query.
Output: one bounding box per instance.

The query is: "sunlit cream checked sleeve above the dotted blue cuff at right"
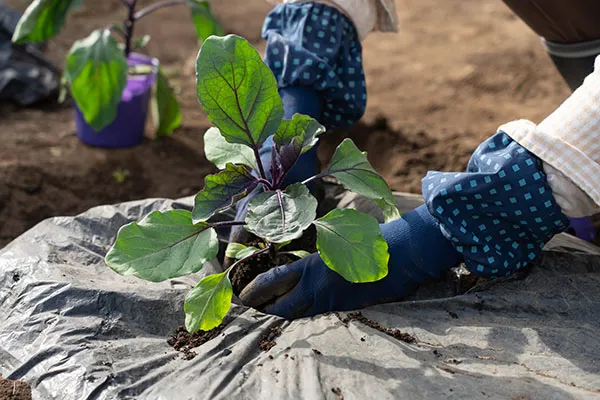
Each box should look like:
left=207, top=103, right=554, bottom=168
left=500, top=57, right=600, bottom=212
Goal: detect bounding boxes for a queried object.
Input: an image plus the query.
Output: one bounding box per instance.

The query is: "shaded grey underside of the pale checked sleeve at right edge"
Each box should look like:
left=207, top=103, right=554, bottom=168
left=543, top=163, right=600, bottom=218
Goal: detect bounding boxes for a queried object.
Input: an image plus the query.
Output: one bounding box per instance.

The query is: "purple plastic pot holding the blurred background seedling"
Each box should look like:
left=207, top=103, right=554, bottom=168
left=74, top=53, right=158, bottom=148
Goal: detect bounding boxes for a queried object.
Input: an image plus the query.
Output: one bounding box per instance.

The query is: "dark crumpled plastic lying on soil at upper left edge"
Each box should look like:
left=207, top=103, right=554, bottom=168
left=0, top=4, right=58, bottom=106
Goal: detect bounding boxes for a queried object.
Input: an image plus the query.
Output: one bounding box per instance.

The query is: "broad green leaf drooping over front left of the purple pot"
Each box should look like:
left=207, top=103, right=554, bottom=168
left=65, top=29, right=127, bottom=131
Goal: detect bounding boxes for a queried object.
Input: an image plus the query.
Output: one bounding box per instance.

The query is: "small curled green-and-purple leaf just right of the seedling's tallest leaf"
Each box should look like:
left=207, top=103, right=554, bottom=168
left=273, top=114, right=325, bottom=171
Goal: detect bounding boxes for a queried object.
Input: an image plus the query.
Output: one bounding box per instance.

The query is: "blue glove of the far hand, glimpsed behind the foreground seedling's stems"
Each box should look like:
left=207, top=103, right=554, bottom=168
left=223, top=87, right=323, bottom=268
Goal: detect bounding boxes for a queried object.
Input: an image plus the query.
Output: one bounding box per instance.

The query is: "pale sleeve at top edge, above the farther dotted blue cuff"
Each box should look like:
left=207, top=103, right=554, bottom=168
left=269, top=0, right=398, bottom=41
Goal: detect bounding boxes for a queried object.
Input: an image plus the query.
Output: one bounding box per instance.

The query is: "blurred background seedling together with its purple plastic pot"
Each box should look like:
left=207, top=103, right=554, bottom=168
left=13, top=0, right=224, bottom=148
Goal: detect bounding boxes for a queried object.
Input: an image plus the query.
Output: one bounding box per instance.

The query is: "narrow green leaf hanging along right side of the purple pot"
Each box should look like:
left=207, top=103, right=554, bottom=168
left=152, top=68, right=181, bottom=137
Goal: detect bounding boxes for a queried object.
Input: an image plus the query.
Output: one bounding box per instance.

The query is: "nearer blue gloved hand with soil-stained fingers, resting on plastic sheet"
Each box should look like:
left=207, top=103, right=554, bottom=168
left=240, top=205, right=461, bottom=319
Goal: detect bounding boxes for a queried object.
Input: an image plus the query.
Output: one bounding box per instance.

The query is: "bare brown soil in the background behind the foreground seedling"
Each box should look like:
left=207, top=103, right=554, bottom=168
left=0, top=0, right=592, bottom=248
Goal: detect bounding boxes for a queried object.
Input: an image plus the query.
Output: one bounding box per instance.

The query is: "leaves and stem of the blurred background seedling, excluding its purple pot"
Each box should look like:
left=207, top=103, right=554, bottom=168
left=12, top=0, right=224, bottom=136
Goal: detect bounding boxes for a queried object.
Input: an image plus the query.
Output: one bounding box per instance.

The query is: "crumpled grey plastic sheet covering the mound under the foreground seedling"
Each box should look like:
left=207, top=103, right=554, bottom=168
left=0, top=195, right=600, bottom=400
